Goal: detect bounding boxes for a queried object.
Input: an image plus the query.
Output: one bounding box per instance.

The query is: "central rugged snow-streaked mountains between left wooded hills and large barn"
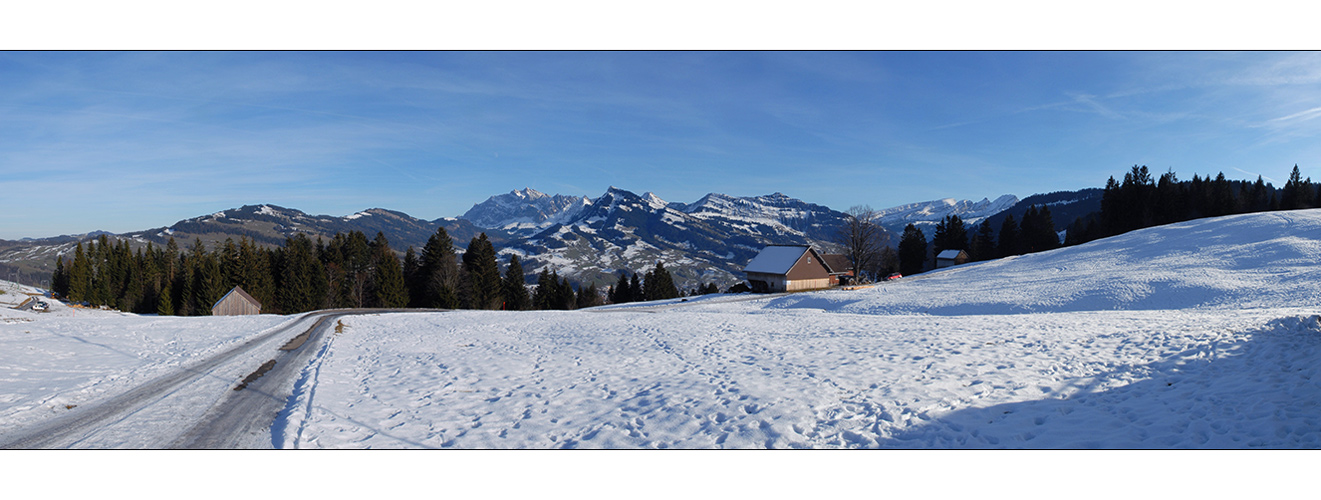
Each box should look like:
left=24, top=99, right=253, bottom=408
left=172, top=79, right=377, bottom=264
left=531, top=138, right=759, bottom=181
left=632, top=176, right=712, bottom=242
left=483, top=187, right=844, bottom=286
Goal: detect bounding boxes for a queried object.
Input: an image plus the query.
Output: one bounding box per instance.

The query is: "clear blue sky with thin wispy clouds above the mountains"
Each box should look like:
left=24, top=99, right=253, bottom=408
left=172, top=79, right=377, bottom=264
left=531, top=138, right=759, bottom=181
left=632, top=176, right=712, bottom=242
left=0, top=51, right=1321, bottom=239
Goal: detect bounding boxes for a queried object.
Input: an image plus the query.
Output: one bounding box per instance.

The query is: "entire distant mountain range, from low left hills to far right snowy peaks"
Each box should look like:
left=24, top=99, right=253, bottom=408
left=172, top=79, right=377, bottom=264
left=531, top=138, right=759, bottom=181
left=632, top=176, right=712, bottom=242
left=0, top=187, right=1018, bottom=288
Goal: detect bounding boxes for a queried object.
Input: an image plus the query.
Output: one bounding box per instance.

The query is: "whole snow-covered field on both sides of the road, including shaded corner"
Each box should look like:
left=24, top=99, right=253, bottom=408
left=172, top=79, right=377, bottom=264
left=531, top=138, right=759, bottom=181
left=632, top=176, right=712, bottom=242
left=0, top=210, right=1321, bottom=449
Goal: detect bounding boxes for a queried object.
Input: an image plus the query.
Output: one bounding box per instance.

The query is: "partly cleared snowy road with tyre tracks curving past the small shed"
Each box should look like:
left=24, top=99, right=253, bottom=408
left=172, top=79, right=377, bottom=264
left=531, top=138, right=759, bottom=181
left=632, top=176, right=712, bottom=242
left=0, top=310, right=441, bottom=449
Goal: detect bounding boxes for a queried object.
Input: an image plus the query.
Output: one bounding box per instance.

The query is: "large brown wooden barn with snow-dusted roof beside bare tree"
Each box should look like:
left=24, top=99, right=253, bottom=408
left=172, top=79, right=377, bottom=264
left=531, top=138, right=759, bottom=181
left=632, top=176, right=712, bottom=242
left=744, top=245, right=832, bottom=293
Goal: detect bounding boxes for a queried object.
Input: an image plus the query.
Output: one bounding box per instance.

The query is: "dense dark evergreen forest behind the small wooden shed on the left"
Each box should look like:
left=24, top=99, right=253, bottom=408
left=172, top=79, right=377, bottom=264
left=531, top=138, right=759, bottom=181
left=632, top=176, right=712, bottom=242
left=52, top=228, right=692, bottom=315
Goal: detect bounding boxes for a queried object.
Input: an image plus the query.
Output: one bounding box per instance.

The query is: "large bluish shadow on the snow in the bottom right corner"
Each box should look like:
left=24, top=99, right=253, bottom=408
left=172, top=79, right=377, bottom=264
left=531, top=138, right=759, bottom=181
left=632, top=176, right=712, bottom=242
left=876, top=317, right=1321, bottom=449
